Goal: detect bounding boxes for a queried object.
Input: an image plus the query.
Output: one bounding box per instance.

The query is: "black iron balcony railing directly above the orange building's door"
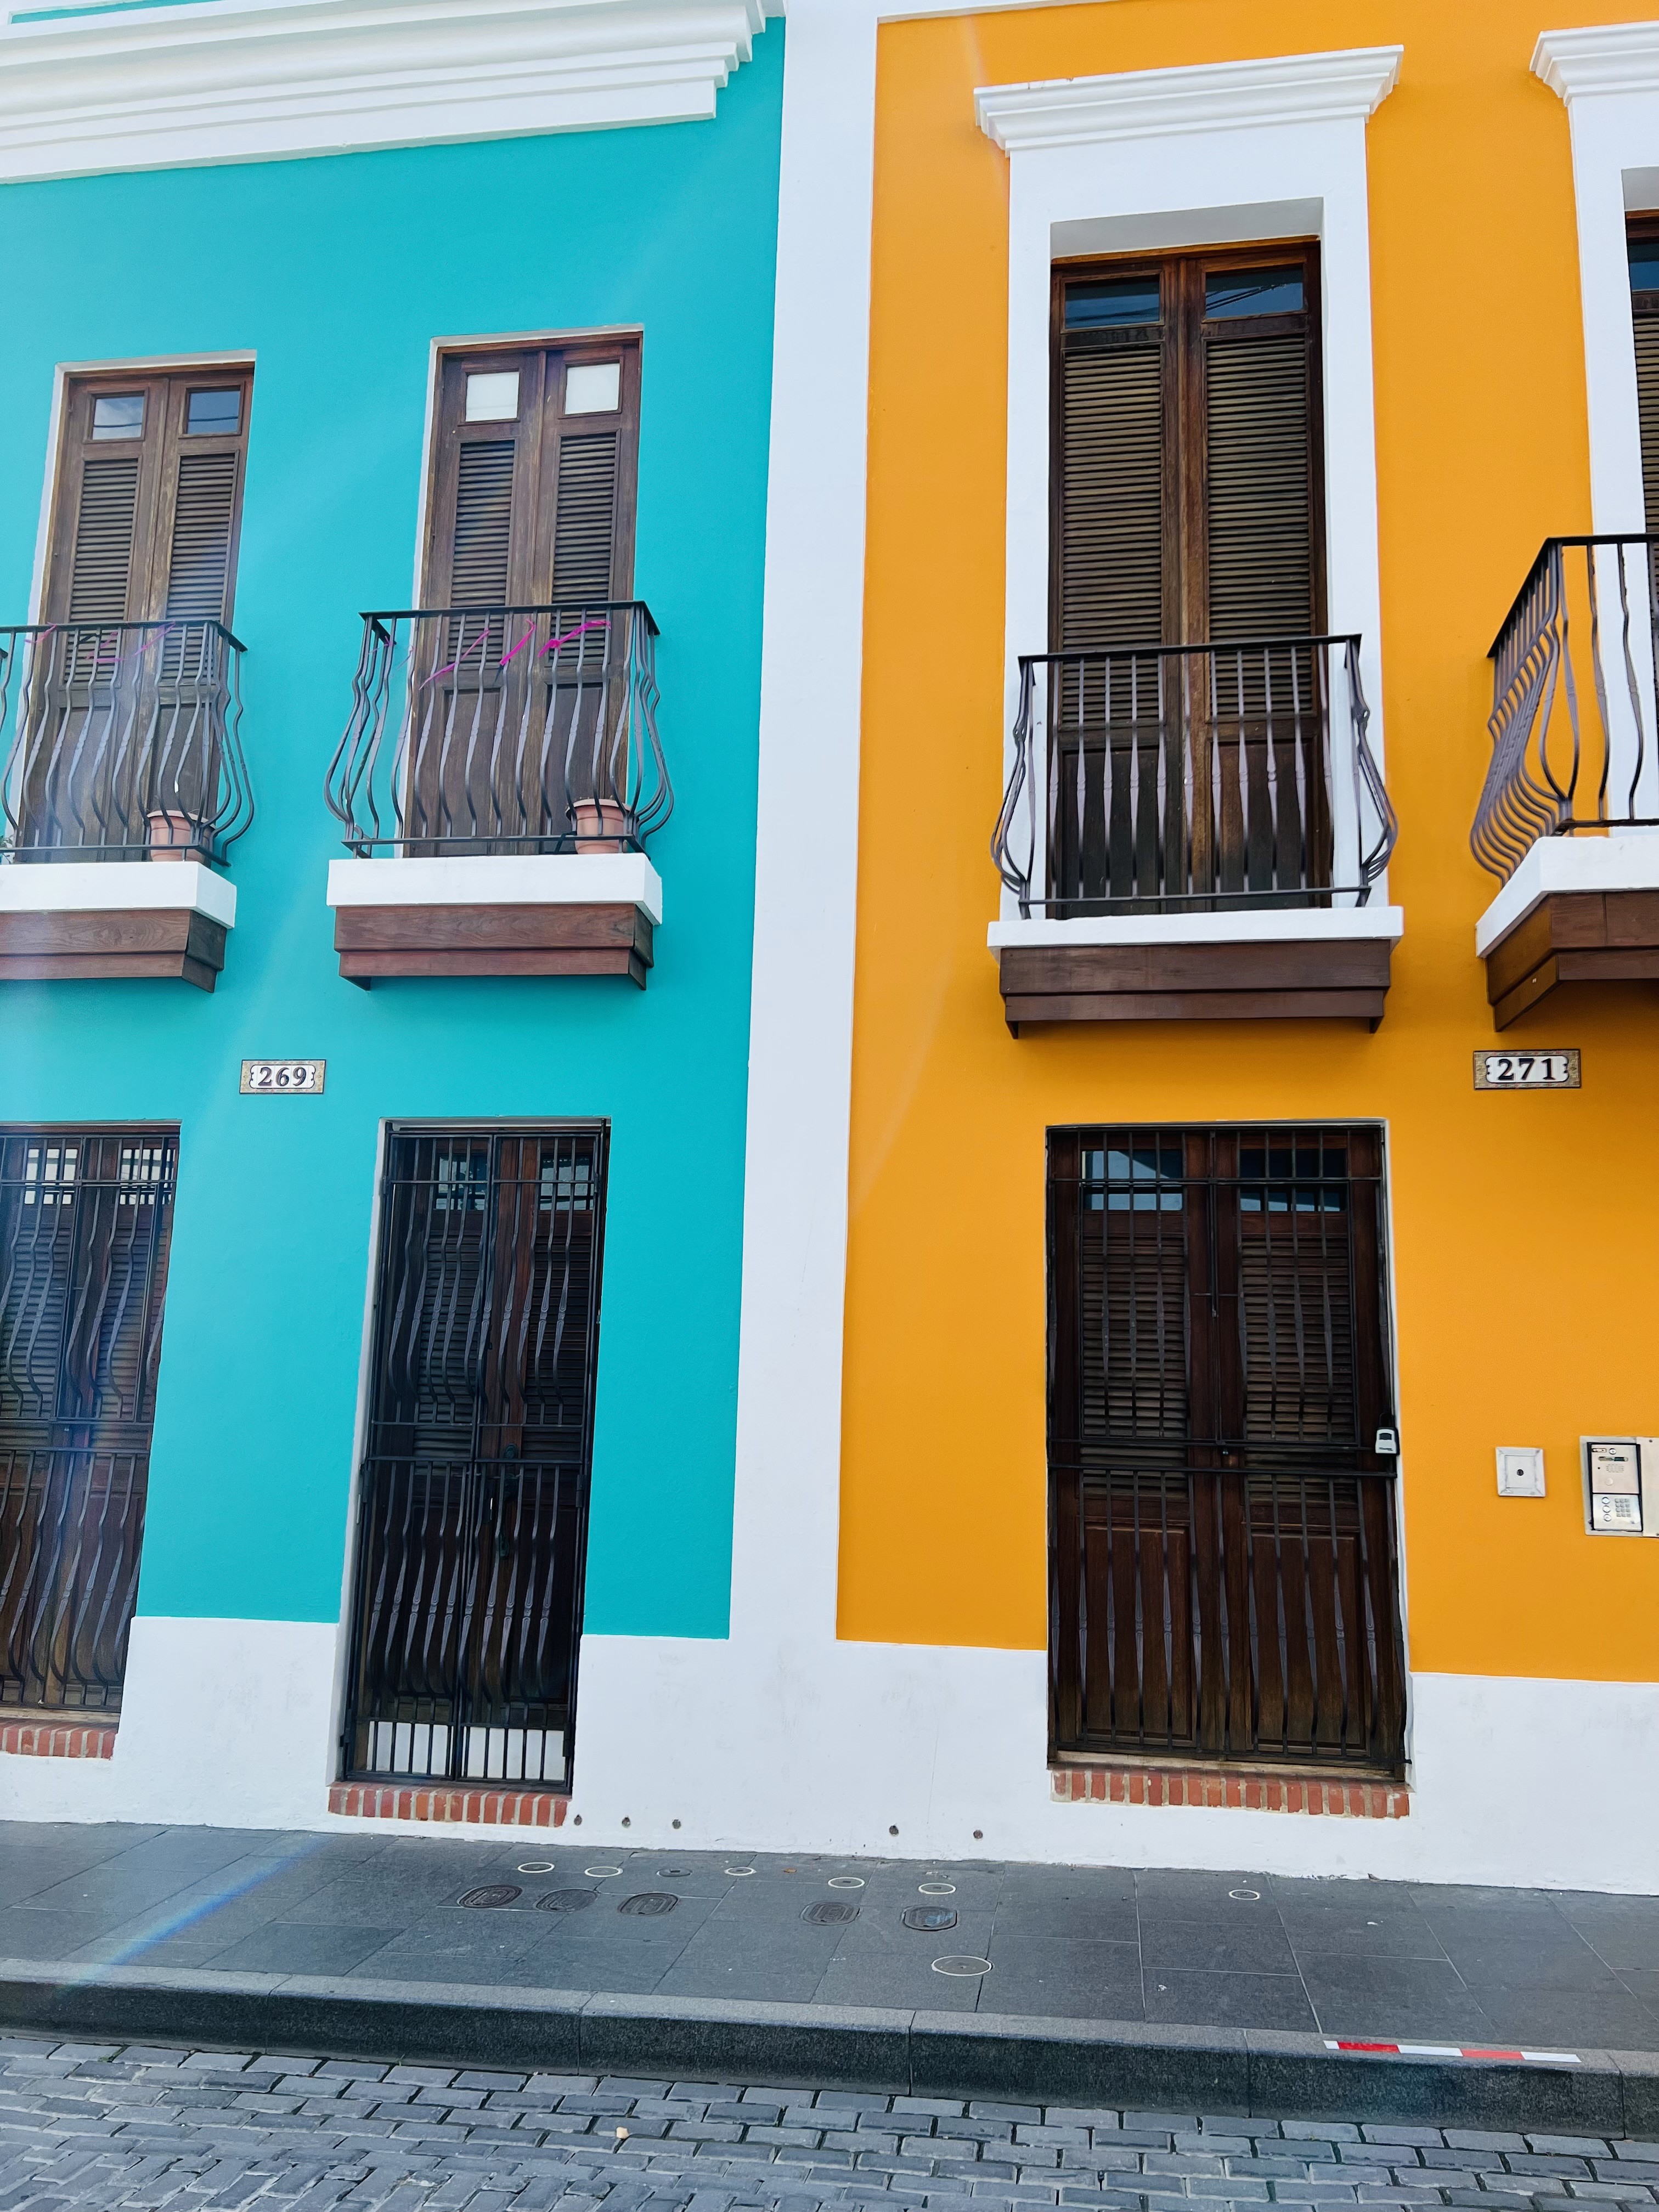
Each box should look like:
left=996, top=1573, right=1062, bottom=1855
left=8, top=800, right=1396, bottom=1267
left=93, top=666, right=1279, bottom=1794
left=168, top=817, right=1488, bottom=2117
left=991, top=637, right=1398, bottom=920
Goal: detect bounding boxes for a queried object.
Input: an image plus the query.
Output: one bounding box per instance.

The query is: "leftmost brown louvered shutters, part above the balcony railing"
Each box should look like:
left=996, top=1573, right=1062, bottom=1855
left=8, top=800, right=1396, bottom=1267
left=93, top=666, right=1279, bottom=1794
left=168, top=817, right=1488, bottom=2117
left=42, top=367, right=252, bottom=622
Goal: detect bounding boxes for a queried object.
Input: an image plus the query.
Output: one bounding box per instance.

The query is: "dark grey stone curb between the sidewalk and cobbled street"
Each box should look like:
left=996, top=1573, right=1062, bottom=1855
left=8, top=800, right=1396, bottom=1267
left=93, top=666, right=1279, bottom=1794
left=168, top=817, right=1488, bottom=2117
left=0, top=1960, right=1659, bottom=2137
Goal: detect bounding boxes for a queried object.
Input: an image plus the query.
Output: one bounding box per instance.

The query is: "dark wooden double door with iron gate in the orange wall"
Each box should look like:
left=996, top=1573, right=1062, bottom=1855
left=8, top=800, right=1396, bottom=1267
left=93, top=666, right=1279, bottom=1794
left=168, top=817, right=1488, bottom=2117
left=1048, top=1128, right=1404, bottom=1774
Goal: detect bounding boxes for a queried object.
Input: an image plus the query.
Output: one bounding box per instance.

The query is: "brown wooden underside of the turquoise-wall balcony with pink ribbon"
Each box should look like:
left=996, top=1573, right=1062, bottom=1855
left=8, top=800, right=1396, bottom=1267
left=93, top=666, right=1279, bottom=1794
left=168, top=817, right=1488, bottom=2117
left=334, top=905, right=652, bottom=991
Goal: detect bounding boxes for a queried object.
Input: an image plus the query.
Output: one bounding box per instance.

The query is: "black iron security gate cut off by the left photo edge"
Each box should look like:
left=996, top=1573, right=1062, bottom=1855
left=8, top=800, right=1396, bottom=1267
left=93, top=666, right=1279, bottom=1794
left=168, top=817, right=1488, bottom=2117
left=0, top=1128, right=179, bottom=1714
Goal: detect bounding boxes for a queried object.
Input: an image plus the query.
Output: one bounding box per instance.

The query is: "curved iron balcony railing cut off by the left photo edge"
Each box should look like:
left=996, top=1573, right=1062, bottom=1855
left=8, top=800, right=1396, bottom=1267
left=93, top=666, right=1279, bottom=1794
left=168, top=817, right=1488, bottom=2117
left=0, top=622, right=255, bottom=865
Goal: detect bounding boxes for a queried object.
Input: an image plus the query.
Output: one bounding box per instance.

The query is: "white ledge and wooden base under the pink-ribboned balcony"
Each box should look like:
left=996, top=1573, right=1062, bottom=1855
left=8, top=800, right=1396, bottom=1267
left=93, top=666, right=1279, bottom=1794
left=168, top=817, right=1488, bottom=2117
left=328, top=851, right=662, bottom=989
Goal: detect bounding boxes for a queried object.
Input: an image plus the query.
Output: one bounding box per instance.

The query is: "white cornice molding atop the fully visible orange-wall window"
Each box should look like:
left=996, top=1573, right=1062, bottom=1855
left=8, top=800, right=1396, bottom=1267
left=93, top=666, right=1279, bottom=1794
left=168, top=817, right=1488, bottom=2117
left=973, top=47, right=1404, bottom=153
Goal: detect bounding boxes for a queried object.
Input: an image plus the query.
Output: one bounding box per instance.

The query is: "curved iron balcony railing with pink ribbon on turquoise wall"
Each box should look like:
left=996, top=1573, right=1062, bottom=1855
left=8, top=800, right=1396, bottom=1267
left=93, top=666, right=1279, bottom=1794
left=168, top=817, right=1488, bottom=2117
left=328, top=600, right=675, bottom=858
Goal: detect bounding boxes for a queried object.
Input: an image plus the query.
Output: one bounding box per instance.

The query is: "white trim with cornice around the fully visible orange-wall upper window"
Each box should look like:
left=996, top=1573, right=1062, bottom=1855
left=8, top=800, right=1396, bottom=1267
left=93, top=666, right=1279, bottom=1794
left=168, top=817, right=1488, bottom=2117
left=975, top=47, right=1402, bottom=936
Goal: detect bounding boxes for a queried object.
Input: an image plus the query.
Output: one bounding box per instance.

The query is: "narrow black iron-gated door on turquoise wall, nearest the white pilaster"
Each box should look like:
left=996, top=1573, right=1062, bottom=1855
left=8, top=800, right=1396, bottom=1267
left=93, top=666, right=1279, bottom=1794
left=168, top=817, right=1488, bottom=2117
left=343, top=1128, right=604, bottom=1787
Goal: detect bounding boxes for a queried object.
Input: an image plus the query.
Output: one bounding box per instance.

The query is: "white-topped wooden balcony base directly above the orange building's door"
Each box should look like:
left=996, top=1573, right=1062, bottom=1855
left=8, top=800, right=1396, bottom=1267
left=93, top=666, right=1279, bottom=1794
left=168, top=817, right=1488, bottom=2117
left=989, top=905, right=1404, bottom=1035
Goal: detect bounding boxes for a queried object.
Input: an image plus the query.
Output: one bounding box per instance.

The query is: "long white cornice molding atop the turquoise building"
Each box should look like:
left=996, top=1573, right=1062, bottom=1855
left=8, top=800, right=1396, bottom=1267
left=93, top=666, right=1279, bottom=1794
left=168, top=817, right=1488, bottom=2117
left=0, top=0, right=765, bottom=182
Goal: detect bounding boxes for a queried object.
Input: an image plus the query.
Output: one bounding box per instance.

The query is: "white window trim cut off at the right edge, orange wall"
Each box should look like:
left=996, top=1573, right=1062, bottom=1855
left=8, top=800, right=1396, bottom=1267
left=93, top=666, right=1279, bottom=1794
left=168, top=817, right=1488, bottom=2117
left=1539, top=22, right=1659, bottom=531
